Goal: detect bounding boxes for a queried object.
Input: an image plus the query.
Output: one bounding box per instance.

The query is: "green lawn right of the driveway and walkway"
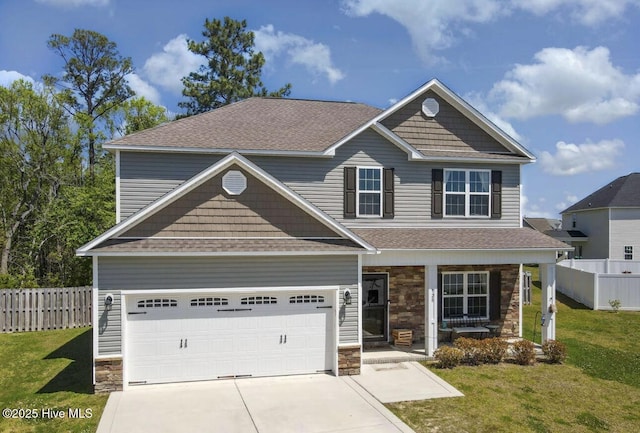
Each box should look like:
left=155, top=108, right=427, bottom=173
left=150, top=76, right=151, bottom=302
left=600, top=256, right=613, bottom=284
left=389, top=268, right=640, bottom=433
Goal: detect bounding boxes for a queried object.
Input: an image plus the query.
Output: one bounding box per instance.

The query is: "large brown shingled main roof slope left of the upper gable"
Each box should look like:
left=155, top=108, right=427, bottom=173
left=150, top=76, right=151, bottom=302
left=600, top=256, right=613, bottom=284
left=109, top=97, right=382, bottom=152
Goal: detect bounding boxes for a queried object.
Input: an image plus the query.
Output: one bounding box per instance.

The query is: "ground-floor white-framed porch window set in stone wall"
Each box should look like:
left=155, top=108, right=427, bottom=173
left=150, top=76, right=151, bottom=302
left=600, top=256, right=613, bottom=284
left=442, top=272, right=489, bottom=320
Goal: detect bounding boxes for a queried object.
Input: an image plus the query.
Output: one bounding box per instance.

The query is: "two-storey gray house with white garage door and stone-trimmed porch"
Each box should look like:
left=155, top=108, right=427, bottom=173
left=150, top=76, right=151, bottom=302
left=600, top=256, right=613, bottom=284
left=77, top=80, right=568, bottom=391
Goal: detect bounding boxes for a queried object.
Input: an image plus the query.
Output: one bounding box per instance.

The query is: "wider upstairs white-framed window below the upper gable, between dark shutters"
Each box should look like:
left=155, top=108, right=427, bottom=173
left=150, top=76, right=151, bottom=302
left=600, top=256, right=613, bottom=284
left=444, top=169, right=491, bottom=217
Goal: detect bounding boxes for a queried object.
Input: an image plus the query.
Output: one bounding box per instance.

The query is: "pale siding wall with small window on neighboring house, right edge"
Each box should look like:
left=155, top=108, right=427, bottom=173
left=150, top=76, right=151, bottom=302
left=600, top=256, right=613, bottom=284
left=609, top=208, right=640, bottom=260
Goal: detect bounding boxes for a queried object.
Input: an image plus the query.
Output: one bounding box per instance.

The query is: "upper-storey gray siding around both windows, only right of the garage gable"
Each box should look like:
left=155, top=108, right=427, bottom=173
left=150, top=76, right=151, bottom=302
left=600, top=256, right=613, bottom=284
left=251, top=131, right=520, bottom=227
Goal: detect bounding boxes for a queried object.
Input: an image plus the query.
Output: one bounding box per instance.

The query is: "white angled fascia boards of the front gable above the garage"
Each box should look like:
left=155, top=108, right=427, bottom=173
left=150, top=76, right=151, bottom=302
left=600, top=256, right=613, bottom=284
left=76, top=152, right=376, bottom=256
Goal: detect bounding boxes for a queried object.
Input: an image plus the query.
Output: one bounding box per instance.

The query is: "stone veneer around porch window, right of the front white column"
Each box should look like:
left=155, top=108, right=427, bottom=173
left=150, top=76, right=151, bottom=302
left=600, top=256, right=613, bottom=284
left=438, top=265, right=520, bottom=337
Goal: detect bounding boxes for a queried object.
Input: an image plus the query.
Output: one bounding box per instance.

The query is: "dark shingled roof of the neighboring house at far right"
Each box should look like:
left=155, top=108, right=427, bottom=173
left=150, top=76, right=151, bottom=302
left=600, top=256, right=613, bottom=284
left=561, top=173, right=640, bottom=213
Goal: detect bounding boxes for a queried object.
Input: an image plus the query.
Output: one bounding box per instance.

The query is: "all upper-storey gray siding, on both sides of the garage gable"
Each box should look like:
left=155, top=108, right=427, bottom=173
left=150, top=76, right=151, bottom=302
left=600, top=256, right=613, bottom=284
left=120, top=130, right=520, bottom=227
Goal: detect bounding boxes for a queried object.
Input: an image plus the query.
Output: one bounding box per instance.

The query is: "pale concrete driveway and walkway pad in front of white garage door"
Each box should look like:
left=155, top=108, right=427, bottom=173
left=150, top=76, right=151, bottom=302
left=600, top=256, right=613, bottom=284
left=98, top=363, right=461, bottom=433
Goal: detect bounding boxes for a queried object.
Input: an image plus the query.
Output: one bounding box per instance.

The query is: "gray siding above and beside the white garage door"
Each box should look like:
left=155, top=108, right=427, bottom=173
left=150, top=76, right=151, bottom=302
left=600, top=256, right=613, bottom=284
left=98, top=256, right=358, bottom=356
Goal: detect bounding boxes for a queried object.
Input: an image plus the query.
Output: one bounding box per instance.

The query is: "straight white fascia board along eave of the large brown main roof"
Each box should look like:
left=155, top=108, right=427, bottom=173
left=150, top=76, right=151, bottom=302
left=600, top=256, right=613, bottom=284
left=102, top=144, right=330, bottom=158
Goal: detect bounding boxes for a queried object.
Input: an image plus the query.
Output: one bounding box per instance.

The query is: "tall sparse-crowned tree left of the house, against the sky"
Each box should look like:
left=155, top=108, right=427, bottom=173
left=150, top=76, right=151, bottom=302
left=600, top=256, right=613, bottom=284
left=45, top=29, right=134, bottom=176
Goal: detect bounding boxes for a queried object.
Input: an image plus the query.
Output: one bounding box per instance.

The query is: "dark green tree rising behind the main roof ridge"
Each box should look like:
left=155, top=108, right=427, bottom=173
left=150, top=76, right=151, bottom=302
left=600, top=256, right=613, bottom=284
left=178, top=17, right=291, bottom=116
